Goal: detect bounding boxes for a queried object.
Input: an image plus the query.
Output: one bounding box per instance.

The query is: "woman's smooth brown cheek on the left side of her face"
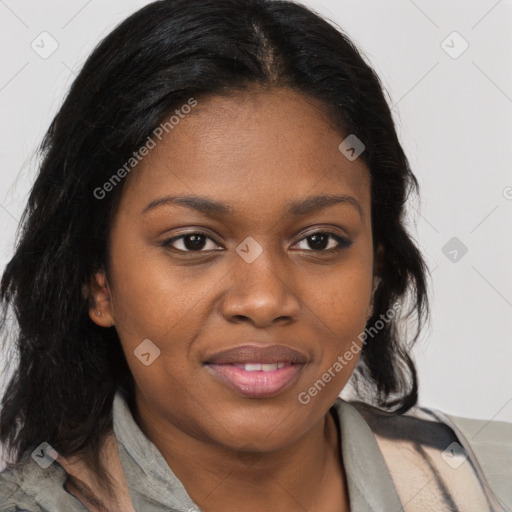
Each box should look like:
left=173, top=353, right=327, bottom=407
left=111, top=228, right=222, bottom=392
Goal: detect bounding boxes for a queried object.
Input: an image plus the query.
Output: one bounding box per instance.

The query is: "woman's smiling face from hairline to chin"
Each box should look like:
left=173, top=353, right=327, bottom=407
left=91, top=89, right=373, bottom=451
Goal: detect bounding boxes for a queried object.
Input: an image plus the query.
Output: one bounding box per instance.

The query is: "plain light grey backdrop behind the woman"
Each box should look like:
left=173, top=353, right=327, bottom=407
left=0, top=0, right=512, bottom=428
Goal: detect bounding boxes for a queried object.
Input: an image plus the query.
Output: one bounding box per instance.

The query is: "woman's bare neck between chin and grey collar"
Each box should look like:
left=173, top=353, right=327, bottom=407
left=136, top=400, right=348, bottom=512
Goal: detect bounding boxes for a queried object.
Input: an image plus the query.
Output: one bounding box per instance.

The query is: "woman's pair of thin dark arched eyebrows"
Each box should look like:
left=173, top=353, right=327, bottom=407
left=142, top=194, right=363, bottom=218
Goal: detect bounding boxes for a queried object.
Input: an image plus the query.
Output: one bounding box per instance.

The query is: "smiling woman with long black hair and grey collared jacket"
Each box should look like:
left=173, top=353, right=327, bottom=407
left=0, top=0, right=512, bottom=512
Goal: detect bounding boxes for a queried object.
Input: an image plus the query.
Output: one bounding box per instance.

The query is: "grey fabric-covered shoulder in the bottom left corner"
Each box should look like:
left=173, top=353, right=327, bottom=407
left=0, top=455, right=73, bottom=512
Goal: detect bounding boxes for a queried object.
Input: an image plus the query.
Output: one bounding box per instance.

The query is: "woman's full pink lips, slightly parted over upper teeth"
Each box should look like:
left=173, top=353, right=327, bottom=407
left=205, top=345, right=308, bottom=398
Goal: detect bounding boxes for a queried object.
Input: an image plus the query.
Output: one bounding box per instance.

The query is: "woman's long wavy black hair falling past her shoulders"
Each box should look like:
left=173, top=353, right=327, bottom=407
left=0, top=0, right=429, bottom=488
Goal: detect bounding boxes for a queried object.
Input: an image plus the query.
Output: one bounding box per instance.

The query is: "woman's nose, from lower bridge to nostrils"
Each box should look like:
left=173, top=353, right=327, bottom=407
left=222, top=251, right=301, bottom=328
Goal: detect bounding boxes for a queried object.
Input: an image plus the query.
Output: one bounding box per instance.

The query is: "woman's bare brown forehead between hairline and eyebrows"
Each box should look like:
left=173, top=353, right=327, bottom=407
left=119, top=88, right=370, bottom=216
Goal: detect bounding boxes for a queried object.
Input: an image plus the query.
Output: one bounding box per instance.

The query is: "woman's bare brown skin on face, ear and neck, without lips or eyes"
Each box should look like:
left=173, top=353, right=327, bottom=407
left=90, top=87, right=376, bottom=512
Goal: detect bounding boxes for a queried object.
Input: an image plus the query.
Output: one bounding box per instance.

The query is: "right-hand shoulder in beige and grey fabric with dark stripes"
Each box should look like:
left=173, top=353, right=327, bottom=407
left=349, top=402, right=512, bottom=510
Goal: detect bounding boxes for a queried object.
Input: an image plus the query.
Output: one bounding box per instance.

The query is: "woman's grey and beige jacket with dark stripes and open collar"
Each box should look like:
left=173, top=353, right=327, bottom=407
left=0, top=391, right=512, bottom=512
